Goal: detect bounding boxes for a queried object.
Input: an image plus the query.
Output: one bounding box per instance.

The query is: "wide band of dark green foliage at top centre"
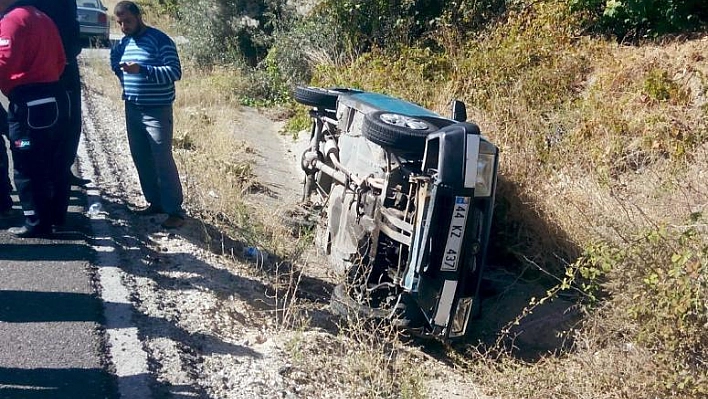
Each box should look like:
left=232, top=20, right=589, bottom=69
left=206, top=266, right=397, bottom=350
left=176, top=0, right=515, bottom=70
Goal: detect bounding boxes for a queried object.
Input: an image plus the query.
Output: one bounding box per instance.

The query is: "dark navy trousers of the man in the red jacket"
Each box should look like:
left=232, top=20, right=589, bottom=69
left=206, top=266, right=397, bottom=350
left=8, top=82, right=73, bottom=229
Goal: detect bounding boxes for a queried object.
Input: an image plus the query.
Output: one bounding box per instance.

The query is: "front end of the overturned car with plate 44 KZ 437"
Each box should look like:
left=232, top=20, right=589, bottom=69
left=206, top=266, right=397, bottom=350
left=402, top=123, right=498, bottom=339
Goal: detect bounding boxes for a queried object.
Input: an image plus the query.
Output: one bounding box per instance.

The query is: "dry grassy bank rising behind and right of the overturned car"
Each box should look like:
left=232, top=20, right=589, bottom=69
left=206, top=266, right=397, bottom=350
left=318, top=2, right=708, bottom=398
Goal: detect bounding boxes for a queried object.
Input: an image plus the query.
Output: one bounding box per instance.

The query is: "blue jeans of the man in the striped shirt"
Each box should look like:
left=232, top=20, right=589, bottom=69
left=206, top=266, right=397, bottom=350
left=125, top=101, right=183, bottom=215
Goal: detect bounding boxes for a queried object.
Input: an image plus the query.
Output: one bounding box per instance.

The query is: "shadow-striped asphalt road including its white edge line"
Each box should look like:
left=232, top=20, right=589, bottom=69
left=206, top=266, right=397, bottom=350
left=0, top=30, right=183, bottom=399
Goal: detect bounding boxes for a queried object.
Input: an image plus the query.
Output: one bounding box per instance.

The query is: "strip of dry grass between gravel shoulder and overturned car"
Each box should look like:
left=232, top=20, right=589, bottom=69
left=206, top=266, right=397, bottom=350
left=85, top=6, right=446, bottom=399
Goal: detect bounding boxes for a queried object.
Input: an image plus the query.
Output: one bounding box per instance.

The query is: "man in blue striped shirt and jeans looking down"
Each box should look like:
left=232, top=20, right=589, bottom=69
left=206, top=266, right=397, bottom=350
left=111, top=1, right=184, bottom=228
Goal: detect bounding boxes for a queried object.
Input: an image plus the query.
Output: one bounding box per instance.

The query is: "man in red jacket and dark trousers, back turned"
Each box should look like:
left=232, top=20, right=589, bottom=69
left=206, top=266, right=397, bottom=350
left=0, top=0, right=69, bottom=237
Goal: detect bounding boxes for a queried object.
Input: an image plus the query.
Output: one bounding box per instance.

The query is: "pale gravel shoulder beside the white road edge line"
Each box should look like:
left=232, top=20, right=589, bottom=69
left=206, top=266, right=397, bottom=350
left=81, top=71, right=314, bottom=398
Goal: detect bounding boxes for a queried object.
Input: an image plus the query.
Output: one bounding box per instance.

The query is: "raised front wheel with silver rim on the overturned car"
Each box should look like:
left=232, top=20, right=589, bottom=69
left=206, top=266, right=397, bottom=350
left=361, top=111, right=438, bottom=153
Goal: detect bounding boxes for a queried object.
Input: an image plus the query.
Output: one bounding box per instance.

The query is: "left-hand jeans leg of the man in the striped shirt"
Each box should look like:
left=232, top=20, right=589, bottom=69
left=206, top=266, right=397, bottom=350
left=125, top=102, right=161, bottom=207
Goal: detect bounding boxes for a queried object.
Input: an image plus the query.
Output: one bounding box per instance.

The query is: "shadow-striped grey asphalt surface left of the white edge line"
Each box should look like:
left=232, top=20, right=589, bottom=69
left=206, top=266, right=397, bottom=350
left=0, top=145, right=118, bottom=399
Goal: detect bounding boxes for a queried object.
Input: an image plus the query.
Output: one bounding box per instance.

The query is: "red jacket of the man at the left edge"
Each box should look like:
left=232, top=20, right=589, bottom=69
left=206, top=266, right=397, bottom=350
left=0, top=6, right=66, bottom=96
